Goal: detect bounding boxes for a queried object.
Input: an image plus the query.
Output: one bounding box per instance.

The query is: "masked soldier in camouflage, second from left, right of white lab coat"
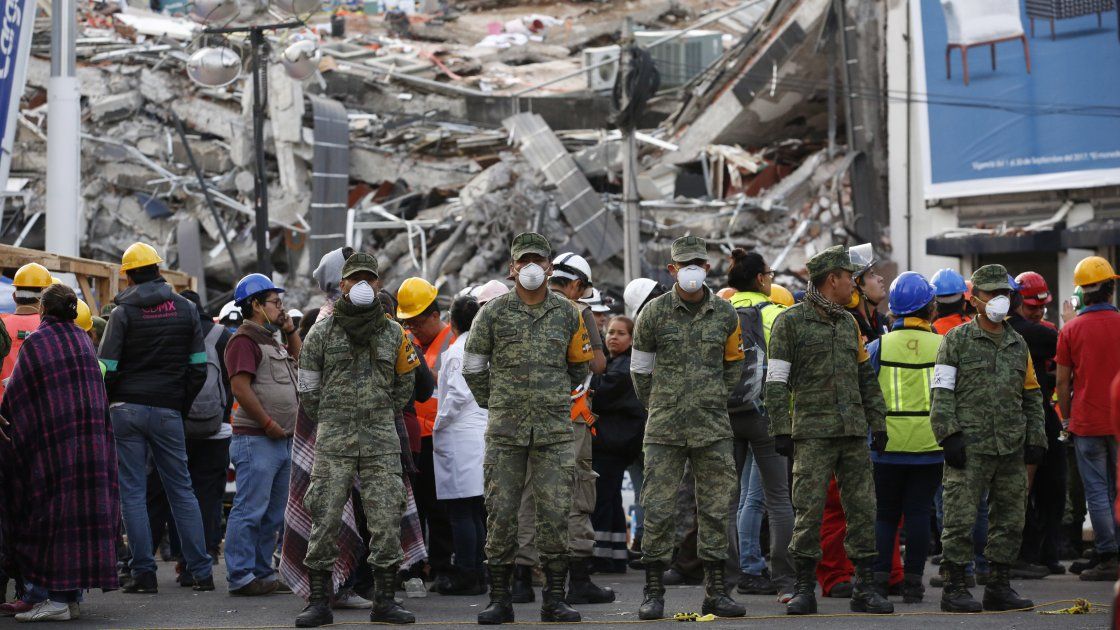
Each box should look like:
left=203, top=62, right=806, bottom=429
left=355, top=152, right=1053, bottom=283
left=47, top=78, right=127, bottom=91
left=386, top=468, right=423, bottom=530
left=463, top=233, right=591, bottom=624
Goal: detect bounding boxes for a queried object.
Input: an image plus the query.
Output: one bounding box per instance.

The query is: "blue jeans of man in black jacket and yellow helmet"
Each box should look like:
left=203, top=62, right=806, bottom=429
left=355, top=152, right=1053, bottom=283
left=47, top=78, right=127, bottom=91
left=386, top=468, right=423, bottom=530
left=115, top=402, right=212, bottom=580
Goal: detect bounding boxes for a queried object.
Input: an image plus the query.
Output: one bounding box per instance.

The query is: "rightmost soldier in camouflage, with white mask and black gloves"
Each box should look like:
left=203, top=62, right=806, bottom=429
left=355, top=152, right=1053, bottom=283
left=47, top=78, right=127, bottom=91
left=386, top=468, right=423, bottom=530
left=930, top=265, right=1046, bottom=612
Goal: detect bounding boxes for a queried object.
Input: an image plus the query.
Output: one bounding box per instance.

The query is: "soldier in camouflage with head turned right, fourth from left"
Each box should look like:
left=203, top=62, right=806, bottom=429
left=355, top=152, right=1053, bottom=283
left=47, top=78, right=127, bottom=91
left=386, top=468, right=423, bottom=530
left=765, top=245, right=894, bottom=614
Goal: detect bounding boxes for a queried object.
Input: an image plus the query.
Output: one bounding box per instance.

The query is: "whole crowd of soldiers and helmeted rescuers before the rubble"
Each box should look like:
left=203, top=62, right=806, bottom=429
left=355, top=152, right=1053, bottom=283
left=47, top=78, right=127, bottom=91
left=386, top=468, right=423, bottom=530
left=0, top=233, right=1120, bottom=627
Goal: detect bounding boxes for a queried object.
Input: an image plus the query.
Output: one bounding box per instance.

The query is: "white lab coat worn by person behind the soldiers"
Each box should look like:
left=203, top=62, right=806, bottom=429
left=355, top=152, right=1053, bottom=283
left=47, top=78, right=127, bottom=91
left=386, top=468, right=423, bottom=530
left=431, top=333, right=488, bottom=499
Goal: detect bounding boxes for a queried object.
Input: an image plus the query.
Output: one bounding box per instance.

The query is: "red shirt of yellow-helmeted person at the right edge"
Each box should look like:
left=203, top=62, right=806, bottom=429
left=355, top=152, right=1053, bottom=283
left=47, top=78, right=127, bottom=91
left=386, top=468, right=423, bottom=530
left=1054, top=307, right=1120, bottom=436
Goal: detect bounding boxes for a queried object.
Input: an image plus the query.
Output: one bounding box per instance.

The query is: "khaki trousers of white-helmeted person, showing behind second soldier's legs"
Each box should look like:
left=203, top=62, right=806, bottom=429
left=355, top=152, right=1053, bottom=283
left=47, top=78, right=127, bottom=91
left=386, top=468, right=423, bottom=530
left=516, top=423, right=599, bottom=566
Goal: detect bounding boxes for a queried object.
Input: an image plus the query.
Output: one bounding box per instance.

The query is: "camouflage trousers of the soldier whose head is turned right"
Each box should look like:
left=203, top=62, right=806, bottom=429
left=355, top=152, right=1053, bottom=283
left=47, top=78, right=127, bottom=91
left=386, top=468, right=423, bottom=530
left=790, top=437, right=873, bottom=563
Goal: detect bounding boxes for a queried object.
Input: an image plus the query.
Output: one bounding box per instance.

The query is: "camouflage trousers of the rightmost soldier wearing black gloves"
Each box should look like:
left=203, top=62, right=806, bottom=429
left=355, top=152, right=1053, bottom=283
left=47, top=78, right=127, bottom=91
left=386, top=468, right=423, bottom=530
left=941, top=452, right=1027, bottom=564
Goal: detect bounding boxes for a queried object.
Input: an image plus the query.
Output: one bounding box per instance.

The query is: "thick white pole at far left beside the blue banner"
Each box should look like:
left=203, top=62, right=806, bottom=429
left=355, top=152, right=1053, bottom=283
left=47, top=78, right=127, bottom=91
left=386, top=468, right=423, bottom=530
left=46, top=0, right=82, bottom=256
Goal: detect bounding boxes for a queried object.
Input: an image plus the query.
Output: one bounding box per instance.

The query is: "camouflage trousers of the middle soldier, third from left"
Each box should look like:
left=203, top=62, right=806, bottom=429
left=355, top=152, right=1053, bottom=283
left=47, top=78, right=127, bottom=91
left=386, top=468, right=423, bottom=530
left=642, top=439, right=738, bottom=563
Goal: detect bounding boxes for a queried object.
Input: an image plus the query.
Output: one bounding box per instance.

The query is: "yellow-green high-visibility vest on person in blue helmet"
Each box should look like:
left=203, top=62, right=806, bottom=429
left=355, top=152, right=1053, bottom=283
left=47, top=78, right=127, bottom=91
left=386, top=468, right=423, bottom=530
left=879, top=328, right=943, bottom=453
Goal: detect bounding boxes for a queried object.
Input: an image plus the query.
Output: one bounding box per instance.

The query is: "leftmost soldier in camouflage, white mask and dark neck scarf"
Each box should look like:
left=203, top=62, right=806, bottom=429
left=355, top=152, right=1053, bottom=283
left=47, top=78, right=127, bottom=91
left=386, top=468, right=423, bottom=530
left=296, top=253, right=420, bottom=628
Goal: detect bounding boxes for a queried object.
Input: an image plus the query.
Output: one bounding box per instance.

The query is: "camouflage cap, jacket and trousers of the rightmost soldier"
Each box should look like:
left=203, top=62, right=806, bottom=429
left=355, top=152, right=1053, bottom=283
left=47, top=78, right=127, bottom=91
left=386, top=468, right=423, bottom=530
left=930, top=265, right=1046, bottom=565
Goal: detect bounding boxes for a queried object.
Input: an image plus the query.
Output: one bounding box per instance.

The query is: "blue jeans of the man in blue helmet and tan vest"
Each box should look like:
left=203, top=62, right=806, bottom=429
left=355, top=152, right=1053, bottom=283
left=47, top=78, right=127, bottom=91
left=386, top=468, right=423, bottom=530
left=225, top=435, right=291, bottom=591
